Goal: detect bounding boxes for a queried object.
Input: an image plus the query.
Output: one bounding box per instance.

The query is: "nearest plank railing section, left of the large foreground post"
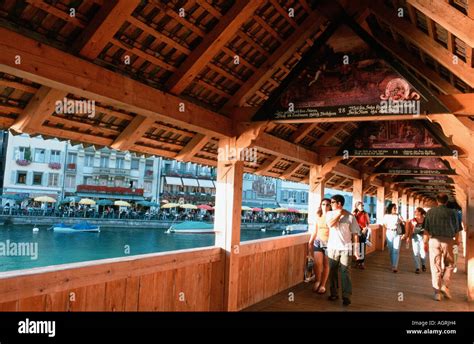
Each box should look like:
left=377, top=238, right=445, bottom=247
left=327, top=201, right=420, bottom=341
left=0, top=248, right=224, bottom=311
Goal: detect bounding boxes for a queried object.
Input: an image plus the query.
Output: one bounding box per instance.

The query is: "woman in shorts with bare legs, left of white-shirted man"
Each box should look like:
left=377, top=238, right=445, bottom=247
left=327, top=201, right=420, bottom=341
left=309, top=198, right=331, bottom=294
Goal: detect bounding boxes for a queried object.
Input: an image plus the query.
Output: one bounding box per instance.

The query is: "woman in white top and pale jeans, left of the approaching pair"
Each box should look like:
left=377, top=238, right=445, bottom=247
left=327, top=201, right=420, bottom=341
left=382, top=203, right=403, bottom=273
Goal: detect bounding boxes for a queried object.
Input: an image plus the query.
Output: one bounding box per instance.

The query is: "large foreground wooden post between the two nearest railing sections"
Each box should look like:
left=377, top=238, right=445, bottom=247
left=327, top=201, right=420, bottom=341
left=214, top=138, right=244, bottom=311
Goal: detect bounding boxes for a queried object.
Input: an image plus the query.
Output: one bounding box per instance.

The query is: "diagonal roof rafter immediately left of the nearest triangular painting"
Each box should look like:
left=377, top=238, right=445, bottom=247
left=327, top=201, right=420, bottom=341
left=225, top=12, right=325, bottom=109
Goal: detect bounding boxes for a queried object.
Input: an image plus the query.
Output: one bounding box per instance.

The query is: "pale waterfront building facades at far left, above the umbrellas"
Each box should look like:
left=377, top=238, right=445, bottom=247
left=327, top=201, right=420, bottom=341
left=3, top=134, right=161, bottom=203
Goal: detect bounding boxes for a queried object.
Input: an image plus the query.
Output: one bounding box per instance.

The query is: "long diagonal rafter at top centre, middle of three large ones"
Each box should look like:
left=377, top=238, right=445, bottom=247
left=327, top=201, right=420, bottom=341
left=167, top=0, right=263, bottom=94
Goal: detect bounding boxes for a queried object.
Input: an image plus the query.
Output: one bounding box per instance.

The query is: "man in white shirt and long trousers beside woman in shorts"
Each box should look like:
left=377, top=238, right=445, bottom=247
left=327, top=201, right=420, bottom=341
left=326, top=195, right=360, bottom=306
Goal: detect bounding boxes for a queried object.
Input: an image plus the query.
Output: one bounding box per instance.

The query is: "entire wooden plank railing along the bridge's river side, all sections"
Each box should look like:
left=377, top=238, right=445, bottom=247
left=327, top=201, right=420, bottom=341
left=0, top=225, right=383, bottom=311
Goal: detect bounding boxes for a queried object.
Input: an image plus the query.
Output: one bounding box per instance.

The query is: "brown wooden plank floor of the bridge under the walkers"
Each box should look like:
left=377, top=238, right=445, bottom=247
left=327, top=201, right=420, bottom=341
left=245, top=247, right=474, bottom=311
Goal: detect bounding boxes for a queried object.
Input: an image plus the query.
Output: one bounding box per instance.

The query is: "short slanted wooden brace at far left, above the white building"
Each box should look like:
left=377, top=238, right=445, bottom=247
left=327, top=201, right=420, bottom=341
left=11, top=86, right=67, bottom=134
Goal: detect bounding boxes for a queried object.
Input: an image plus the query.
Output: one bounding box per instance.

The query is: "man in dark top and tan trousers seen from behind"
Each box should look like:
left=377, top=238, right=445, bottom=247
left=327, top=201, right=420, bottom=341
left=425, top=194, right=461, bottom=301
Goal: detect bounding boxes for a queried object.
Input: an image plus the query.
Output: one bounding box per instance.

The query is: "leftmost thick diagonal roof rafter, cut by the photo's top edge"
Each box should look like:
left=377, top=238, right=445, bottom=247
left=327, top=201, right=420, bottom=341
left=73, top=0, right=140, bottom=60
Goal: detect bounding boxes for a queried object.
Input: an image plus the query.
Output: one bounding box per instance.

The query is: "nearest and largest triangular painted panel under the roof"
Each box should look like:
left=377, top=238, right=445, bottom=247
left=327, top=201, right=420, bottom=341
left=253, top=24, right=449, bottom=122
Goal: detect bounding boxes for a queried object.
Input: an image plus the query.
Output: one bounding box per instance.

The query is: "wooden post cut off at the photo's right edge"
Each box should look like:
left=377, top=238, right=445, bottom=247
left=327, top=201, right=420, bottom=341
left=466, top=185, right=474, bottom=301
